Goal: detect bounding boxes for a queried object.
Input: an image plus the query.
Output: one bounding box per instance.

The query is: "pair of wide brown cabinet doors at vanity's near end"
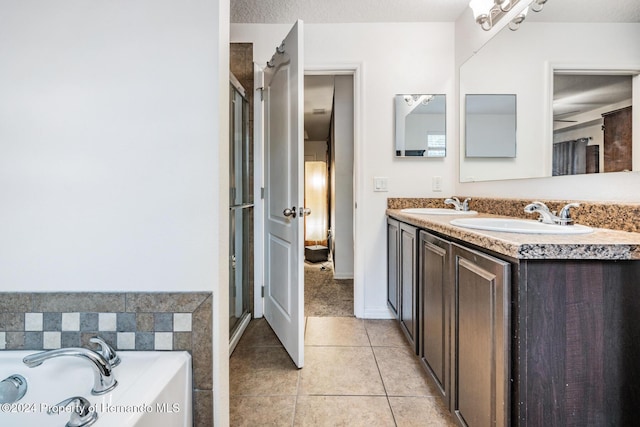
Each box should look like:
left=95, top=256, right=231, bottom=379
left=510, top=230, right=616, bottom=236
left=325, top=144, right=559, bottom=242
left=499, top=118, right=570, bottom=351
left=418, top=234, right=511, bottom=427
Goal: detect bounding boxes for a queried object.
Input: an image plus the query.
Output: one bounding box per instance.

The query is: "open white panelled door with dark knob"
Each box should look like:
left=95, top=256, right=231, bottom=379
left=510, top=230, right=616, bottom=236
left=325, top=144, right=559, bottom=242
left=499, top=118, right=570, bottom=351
left=263, top=21, right=304, bottom=368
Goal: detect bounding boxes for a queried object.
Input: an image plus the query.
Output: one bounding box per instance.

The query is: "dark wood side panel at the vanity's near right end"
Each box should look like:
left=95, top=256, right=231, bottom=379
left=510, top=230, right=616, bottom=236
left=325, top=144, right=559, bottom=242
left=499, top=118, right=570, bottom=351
left=511, top=259, right=640, bottom=427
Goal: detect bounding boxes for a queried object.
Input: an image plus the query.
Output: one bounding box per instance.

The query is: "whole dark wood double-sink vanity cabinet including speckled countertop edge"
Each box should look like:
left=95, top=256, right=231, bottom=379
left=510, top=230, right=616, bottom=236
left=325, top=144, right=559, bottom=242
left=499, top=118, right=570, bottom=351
left=389, top=212, right=640, bottom=427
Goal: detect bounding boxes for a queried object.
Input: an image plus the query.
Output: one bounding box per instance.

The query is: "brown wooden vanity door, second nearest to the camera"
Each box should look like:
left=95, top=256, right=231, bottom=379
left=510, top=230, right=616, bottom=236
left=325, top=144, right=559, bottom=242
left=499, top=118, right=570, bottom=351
left=418, top=231, right=452, bottom=407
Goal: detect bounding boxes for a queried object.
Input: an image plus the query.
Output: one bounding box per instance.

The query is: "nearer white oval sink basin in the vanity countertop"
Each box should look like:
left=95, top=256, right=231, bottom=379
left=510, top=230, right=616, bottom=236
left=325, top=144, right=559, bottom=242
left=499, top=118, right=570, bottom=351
left=449, top=218, right=593, bottom=234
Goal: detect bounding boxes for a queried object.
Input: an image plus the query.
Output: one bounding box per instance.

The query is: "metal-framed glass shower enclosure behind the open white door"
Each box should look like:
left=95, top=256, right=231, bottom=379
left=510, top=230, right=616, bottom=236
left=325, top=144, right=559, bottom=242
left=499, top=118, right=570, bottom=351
left=229, top=74, right=253, bottom=354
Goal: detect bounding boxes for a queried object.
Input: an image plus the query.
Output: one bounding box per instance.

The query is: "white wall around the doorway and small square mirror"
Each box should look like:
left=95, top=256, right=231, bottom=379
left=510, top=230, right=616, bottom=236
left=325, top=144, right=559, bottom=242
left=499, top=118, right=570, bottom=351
left=231, top=23, right=456, bottom=317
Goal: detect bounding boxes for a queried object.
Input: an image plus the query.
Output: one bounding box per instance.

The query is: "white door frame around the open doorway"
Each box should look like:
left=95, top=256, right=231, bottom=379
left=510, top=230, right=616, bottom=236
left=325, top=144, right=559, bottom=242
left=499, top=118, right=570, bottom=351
left=253, top=63, right=365, bottom=318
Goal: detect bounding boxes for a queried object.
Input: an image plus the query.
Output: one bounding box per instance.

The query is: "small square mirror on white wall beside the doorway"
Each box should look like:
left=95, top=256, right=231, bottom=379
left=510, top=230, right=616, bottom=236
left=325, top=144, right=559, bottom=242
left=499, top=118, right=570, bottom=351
left=395, top=94, right=447, bottom=157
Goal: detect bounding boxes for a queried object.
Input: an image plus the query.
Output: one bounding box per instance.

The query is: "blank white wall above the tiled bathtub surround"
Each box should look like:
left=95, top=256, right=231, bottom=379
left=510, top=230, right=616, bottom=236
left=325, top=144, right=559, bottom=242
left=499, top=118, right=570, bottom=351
left=0, top=0, right=226, bottom=291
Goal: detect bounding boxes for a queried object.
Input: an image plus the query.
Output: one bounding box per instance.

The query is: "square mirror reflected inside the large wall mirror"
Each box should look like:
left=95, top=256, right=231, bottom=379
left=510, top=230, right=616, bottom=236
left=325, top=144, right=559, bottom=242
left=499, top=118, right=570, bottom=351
left=464, top=94, right=516, bottom=157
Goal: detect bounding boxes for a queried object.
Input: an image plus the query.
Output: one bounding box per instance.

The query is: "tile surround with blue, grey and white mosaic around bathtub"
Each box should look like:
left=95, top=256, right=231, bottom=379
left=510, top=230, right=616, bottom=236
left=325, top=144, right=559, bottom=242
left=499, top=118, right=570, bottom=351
left=0, top=292, right=213, bottom=426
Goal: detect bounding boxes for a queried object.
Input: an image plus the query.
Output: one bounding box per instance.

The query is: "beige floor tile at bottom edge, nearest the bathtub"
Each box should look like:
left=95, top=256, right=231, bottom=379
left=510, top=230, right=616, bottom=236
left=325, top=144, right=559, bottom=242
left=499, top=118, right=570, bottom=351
left=229, top=396, right=296, bottom=427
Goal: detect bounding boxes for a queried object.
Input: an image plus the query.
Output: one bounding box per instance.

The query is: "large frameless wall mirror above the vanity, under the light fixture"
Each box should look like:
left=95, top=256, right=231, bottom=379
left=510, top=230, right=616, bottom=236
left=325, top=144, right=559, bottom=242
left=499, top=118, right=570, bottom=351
left=460, top=0, right=640, bottom=182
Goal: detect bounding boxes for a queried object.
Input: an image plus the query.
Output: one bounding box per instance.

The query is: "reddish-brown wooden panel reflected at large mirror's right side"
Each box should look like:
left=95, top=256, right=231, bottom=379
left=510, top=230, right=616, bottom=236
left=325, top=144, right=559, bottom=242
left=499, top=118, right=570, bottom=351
left=602, top=107, right=632, bottom=172
